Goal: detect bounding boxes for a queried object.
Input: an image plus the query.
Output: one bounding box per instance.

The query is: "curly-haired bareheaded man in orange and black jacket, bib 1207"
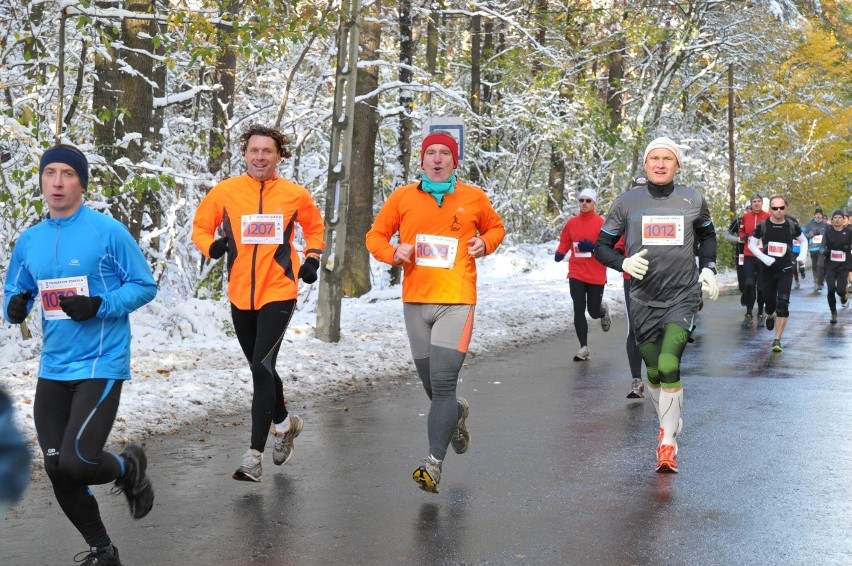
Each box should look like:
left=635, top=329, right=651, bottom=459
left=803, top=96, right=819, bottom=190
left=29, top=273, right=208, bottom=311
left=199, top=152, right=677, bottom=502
left=192, top=125, right=325, bottom=481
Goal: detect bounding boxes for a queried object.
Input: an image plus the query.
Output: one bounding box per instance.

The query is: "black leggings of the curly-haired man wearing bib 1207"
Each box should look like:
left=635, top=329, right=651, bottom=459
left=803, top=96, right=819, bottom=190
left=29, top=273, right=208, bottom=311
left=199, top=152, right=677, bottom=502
left=231, top=299, right=296, bottom=452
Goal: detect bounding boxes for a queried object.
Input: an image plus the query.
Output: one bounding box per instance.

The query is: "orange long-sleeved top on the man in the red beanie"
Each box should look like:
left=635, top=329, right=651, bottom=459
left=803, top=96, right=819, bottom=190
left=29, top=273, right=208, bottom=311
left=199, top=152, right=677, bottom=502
left=367, top=181, right=506, bottom=305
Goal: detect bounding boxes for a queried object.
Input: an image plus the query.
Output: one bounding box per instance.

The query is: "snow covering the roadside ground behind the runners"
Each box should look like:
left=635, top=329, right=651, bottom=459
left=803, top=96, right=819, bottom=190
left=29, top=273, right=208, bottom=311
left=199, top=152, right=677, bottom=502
left=0, top=241, right=736, bottom=462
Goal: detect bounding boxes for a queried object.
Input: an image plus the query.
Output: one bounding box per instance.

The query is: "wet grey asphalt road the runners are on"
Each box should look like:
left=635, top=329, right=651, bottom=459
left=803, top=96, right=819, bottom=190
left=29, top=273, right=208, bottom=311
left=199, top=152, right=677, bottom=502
left=0, top=288, right=852, bottom=566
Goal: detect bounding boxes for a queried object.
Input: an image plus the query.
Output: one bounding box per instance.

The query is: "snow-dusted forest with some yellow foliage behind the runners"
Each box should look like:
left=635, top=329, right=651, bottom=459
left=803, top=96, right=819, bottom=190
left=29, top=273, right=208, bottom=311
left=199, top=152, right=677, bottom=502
left=0, top=0, right=852, bottom=310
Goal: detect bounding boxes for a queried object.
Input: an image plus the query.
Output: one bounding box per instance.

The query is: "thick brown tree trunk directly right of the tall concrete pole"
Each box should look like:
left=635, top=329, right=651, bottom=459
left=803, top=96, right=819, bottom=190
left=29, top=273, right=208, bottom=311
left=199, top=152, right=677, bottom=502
left=341, top=0, right=382, bottom=297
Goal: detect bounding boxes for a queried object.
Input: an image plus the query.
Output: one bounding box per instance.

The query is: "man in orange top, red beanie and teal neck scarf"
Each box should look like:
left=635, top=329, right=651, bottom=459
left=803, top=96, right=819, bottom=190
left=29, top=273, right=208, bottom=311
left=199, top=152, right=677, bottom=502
left=367, top=130, right=506, bottom=493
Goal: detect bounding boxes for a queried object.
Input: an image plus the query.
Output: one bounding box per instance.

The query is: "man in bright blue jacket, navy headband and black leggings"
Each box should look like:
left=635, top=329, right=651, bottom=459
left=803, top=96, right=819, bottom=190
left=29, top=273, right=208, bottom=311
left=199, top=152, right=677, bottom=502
left=3, top=145, right=157, bottom=565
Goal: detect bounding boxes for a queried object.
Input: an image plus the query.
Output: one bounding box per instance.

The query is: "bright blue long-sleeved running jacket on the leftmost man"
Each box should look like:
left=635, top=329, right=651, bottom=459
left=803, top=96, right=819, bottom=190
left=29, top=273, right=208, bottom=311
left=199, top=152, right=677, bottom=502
left=3, top=205, right=157, bottom=381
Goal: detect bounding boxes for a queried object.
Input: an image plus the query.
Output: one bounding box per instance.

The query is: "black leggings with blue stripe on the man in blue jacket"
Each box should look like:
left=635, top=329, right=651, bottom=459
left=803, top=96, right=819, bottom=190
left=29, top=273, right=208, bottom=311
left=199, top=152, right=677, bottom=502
left=33, top=378, right=124, bottom=546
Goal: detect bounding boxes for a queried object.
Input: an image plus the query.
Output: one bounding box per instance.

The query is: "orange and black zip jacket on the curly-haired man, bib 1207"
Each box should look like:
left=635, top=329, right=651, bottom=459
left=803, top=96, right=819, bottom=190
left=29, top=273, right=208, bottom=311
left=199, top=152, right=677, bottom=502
left=192, top=175, right=325, bottom=310
